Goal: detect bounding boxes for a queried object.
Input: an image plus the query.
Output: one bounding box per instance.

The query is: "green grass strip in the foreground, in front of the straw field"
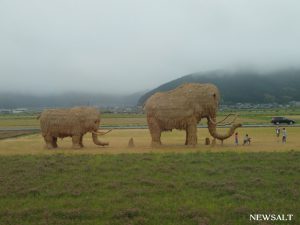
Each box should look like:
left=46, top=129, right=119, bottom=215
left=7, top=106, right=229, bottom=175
left=0, top=151, right=300, bottom=225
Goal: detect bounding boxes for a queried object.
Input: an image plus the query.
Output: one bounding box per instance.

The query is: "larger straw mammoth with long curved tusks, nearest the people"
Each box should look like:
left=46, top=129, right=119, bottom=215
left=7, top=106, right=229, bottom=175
left=144, top=83, right=241, bottom=146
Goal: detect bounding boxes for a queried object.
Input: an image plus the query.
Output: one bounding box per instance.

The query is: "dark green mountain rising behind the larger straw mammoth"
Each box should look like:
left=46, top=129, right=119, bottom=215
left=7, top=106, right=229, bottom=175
left=138, top=69, right=300, bottom=105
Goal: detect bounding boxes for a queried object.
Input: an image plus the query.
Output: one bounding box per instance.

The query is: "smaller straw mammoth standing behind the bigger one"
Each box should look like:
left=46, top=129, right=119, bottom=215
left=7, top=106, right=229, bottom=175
left=39, top=107, right=108, bottom=149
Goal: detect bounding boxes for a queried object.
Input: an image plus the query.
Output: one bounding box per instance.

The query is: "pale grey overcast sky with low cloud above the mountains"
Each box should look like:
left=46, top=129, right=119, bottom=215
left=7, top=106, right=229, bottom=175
left=0, top=0, right=300, bottom=93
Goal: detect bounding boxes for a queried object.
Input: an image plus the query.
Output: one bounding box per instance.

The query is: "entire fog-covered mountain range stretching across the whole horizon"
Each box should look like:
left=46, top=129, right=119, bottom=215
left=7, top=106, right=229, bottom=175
left=0, top=69, right=300, bottom=109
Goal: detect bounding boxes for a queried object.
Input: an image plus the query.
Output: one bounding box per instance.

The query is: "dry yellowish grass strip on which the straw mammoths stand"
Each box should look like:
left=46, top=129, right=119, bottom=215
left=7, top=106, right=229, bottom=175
left=0, top=127, right=300, bottom=155
